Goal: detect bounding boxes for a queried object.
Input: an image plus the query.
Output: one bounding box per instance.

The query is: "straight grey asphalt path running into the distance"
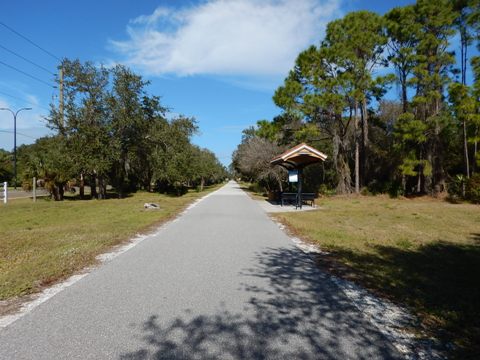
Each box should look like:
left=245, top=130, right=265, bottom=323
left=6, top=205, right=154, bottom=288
left=0, top=182, right=401, bottom=360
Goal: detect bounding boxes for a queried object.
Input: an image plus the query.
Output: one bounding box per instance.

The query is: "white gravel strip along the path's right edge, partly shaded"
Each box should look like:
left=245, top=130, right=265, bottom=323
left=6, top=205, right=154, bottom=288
left=270, top=217, right=445, bottom=360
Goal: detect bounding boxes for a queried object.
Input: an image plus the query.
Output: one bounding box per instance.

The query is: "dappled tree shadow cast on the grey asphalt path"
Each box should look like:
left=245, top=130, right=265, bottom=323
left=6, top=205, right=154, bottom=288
left=120, top=248, right=403, bottom=360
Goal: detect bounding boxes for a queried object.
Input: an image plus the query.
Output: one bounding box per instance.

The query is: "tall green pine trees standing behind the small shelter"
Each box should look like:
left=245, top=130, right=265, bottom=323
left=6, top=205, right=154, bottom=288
left=234, top=0, right=480, bottom=200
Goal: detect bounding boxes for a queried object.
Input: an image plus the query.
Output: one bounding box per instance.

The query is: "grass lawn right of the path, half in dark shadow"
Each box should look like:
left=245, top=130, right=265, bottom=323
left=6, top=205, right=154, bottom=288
left=275, top=196, right=480, bottom=358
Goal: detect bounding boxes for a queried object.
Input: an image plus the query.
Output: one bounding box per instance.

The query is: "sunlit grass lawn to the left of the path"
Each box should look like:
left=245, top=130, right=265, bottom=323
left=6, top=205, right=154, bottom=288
left=0, top=186, right=219, bottom=300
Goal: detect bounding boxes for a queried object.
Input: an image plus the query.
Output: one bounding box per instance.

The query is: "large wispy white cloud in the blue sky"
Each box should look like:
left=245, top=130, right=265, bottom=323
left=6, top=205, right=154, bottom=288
left=110, top=0, right=340, bottom=76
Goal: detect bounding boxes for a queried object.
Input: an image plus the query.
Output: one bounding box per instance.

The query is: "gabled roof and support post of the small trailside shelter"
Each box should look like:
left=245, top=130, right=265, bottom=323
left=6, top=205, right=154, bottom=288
left=270, top=143, right=327, bottom=208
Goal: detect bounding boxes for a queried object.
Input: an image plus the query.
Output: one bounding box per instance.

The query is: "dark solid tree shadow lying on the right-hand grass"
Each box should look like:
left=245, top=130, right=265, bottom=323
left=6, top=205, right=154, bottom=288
left=317, top=239, right=480, bottom=359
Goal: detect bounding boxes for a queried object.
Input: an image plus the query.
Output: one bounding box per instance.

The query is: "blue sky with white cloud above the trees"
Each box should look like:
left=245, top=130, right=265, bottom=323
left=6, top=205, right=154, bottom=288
left=0, top=0, right=418, bottom=165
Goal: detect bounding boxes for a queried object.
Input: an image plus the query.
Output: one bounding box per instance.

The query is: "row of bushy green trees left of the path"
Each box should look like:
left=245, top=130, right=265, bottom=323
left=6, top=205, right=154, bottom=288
left=0, top=59, right=227, bottom=200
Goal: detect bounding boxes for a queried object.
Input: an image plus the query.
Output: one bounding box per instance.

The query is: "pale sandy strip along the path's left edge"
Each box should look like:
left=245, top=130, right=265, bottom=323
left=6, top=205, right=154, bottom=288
left=0, top=186, right=223, bottom=330
